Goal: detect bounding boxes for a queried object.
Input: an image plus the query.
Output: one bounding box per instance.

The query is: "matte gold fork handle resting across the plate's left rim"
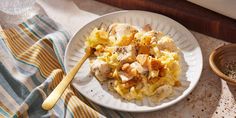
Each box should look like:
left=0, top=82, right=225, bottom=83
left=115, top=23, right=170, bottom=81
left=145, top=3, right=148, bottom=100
left=42, top=53, right=90, bottom=110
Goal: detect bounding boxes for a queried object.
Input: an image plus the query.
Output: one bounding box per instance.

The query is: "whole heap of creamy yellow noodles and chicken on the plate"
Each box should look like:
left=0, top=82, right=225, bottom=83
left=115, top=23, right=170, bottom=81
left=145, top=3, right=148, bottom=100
left=86, top=23, right=181, bottom=102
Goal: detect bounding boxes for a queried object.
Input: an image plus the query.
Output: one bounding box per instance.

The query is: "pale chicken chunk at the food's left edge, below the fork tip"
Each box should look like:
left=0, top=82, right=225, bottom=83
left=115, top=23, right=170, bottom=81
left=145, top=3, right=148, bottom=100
left=91, top=59, right=111, bottom=81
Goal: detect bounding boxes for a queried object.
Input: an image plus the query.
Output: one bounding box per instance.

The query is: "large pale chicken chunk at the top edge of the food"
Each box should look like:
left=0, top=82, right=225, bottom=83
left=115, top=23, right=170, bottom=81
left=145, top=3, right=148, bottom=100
left=109, top=23, right=138, bottom=46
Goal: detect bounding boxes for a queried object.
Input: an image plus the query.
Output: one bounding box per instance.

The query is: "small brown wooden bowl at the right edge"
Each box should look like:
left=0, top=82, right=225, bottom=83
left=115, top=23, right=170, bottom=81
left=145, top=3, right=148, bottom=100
left=209, top=44, right=236, bottom=85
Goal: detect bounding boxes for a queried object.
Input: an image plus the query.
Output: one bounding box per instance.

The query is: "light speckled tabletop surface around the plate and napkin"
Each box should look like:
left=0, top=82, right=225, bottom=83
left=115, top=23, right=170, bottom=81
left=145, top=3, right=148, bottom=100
left=0, top=0, right=236, bottom=118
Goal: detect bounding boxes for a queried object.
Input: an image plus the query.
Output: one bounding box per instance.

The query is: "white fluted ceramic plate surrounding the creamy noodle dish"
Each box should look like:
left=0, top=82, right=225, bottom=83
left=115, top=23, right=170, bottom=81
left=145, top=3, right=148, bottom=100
left=64, top=11, right=203, bottom=112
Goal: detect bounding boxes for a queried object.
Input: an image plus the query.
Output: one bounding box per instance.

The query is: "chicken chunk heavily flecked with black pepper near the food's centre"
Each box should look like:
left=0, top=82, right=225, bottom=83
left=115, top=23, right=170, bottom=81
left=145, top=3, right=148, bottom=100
left=113, top=45, right=136, bottom=63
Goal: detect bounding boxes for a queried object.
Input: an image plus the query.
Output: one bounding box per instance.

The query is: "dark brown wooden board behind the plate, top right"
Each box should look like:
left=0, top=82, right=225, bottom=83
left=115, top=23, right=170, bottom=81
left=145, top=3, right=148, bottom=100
left=97, top=0, right=236, bottom=43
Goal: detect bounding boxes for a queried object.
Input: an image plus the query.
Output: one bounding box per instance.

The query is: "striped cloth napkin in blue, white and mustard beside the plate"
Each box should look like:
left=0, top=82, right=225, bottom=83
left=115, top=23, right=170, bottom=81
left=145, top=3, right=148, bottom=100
left=0, top=15, right=132, bottom=118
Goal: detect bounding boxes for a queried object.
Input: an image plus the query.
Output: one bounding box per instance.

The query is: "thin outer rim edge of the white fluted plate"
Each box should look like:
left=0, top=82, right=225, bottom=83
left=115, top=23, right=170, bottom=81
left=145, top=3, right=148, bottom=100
left=63, top=10, right=203, bottom=113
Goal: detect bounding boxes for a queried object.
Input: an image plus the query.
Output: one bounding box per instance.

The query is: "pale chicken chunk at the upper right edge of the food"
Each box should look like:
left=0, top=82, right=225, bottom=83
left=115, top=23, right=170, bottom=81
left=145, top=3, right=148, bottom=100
left=158, top=36, right=177, bottom=52
